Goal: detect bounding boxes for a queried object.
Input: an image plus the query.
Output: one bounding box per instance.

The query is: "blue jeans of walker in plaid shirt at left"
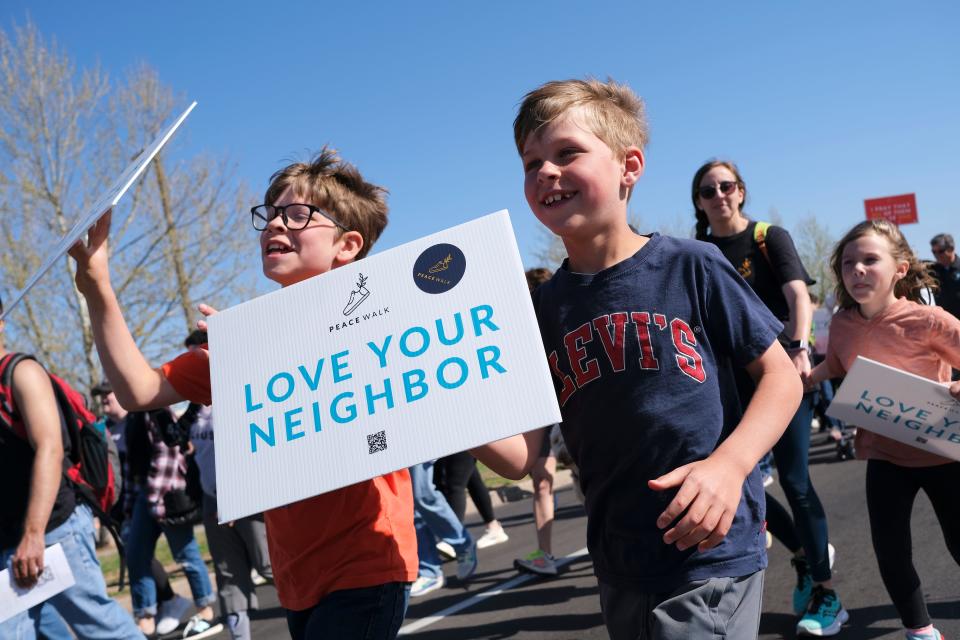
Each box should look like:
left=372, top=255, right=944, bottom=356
left=126, top=487, right=217, bottom=618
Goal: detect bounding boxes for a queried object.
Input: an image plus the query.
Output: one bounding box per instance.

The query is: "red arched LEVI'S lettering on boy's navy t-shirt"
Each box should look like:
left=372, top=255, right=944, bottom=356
left=547, top=311, right=707, bottom=407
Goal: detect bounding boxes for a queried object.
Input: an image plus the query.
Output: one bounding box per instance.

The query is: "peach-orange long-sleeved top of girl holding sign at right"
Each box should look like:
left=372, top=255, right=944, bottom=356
left=826, top=298, right=960, bottom=467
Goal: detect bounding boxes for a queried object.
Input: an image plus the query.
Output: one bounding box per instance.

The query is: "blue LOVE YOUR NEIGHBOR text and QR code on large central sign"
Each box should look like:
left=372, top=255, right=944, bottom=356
left=243, top=304, right=507, bottom=454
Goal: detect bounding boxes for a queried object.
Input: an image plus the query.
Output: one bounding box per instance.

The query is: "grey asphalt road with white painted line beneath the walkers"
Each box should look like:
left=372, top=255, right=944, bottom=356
left=236, top=435, right=960, bottom=640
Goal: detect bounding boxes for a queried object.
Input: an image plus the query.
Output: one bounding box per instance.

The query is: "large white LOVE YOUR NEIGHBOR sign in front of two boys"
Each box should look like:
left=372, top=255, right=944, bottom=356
left=209, top=211, right=560, bottom=521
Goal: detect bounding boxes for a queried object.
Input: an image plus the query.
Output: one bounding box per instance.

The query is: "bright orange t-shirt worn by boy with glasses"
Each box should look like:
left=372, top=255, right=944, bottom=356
left=162, top=352, right=417, bottom=611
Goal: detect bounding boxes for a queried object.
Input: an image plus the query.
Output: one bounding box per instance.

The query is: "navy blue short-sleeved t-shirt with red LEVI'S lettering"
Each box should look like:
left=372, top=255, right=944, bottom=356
left=533, top=234, right=783, bottom=592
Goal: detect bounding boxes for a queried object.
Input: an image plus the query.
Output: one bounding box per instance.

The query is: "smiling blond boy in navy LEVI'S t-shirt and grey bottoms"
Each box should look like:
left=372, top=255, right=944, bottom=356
left=475, top=80, right=802, bottom=640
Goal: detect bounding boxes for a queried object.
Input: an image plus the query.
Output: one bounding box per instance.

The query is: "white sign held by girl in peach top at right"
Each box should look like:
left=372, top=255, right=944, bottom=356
left=827, top=357, right=960, bottom=460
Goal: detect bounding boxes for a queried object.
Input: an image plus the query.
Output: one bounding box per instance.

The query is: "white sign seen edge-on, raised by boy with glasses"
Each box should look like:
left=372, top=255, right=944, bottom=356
left=0, top=101, right=197, bottom=319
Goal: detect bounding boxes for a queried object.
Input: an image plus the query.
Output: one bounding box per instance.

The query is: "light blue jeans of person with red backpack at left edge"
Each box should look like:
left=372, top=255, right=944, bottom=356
left=0, top=505, right=143, bottom=640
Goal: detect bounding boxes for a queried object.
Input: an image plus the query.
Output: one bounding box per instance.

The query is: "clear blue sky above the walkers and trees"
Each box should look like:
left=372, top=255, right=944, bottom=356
left=0, top=0, right=960, bottom=284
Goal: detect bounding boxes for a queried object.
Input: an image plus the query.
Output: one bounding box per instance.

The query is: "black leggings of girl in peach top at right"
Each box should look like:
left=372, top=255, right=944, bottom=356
left=867, top=460, right=960, bottom=629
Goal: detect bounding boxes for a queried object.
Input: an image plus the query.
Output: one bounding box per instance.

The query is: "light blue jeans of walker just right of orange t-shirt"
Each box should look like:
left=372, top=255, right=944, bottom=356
left=410, top=460, right=473, bottom=578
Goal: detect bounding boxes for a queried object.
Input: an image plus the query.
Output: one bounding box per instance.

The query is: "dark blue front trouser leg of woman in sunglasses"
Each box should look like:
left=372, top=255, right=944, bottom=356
left=773, top=393, right=830, bottom=582
